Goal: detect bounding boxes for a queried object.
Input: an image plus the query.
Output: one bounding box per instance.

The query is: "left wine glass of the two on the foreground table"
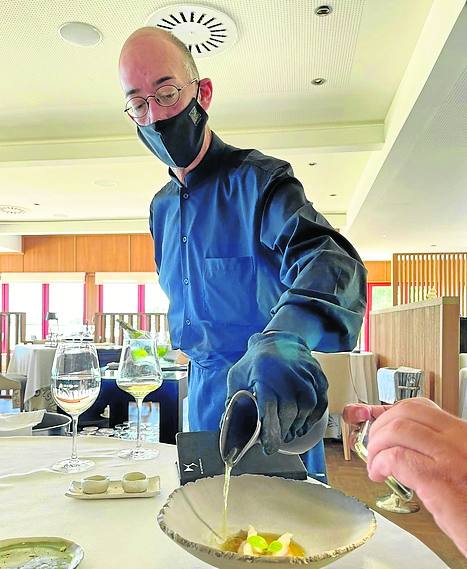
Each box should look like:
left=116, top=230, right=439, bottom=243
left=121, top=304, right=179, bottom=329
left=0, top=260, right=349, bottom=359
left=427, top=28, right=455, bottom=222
left=51, top=342, right=101, bottom=472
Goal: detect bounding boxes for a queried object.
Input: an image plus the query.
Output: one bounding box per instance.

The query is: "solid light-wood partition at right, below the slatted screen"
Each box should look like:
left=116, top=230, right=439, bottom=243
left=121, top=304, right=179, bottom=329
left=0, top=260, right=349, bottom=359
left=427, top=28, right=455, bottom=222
left=370, top=297, right=459, bottom=415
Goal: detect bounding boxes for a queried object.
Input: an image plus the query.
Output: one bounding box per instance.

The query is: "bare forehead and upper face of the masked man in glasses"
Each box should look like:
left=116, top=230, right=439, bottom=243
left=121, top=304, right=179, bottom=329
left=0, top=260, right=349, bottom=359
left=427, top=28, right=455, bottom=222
left=120, top=34, right=198, bottom=124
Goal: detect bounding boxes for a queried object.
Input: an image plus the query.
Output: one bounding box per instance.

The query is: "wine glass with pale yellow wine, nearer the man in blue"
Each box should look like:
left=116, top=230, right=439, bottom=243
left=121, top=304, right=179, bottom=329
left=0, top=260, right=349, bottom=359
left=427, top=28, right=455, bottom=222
left=117, top=335, right=162, bottom=460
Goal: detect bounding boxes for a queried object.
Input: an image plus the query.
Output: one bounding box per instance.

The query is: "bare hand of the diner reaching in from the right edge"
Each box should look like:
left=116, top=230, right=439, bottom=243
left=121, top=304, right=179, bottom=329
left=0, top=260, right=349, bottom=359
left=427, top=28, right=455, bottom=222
left=344, top=398, right=467, bottom=556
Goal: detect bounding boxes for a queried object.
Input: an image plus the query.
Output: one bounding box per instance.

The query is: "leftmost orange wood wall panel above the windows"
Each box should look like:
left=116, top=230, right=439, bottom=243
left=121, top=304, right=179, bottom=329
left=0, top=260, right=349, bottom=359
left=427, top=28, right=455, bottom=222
left=23, top=235, right=76, bottom=273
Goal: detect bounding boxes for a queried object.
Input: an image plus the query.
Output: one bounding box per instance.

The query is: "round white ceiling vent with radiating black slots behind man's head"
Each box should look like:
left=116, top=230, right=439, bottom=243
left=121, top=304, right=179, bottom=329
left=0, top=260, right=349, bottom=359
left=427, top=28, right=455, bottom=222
left=146, top=4, right=237, bottom=57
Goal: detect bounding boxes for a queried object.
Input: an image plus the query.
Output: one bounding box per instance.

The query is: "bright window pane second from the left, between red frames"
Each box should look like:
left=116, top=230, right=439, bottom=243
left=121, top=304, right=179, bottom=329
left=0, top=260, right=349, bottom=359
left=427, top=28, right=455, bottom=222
left=49, top=282, right=84, bottom=337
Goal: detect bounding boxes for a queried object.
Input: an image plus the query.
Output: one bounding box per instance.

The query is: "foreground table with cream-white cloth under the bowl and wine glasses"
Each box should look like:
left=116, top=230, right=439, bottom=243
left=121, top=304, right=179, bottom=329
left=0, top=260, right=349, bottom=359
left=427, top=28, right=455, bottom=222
left=0, top=437, right=447, bottom=569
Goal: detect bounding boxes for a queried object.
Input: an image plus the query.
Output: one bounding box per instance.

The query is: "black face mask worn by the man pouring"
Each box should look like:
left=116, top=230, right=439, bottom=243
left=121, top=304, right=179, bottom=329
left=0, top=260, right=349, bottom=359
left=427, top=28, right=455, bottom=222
left=137, top=97, right=208, bottom=168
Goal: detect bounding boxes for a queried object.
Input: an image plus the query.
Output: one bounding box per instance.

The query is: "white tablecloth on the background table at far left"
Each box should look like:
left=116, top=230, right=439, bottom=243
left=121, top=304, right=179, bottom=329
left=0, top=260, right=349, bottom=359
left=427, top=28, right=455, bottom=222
left=7, top=344, right=55, bottom=401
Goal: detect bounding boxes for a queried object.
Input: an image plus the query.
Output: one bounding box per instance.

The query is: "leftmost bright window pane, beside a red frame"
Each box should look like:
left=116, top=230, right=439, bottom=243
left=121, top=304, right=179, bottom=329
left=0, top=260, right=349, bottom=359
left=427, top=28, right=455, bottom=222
left=8, top=282, right=42, bottom=339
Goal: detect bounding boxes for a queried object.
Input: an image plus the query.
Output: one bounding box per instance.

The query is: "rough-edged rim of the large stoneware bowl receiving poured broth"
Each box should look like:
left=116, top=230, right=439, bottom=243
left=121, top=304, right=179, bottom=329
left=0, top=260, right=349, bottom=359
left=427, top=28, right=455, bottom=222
left=157, top=474, right=376, bottom=565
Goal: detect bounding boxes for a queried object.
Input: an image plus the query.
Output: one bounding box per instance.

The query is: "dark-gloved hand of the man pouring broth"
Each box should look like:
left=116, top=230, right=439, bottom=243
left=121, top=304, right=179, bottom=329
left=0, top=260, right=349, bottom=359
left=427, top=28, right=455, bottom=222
left=227, top=332, right=328, bottom=454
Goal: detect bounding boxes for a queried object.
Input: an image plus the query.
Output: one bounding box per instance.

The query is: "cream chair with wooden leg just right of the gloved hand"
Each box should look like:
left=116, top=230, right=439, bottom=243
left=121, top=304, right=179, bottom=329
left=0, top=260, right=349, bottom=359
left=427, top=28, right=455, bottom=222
left=312, top=352, right=358, bottom=460
